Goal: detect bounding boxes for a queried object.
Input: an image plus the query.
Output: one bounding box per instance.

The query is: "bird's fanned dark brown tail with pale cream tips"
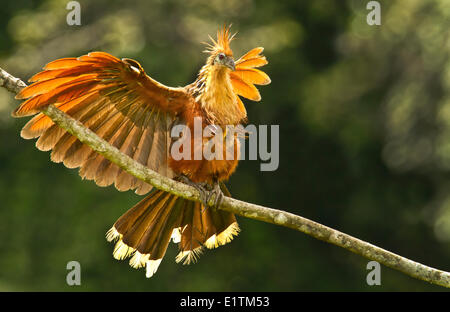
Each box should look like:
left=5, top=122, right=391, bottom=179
left=106, top=185, right=239, bottom=277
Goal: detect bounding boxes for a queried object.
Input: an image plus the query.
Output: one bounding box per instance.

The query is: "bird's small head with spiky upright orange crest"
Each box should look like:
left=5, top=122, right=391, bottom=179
left=205, top=25, right=236, bottom=71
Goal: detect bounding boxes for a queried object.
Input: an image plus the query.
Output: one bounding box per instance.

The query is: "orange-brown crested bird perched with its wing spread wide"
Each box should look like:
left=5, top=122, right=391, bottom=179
left=11, top=25, right=271, bottom=277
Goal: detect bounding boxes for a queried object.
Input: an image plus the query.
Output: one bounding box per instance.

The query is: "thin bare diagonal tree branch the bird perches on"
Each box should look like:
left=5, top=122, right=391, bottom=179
left=0, top=68, right=450, bottom=288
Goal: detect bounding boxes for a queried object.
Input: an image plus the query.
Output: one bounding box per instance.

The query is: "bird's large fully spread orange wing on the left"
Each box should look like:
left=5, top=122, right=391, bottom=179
left=12, top=52, right=193, bottom=194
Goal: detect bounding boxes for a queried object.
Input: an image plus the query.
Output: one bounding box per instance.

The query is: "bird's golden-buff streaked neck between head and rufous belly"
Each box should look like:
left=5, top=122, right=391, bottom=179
left=190, top=65, right=246, bottom=125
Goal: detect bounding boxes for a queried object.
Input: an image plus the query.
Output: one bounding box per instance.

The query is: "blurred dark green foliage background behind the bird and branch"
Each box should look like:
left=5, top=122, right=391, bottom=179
left=0, top=0, right=450, bottom=291
